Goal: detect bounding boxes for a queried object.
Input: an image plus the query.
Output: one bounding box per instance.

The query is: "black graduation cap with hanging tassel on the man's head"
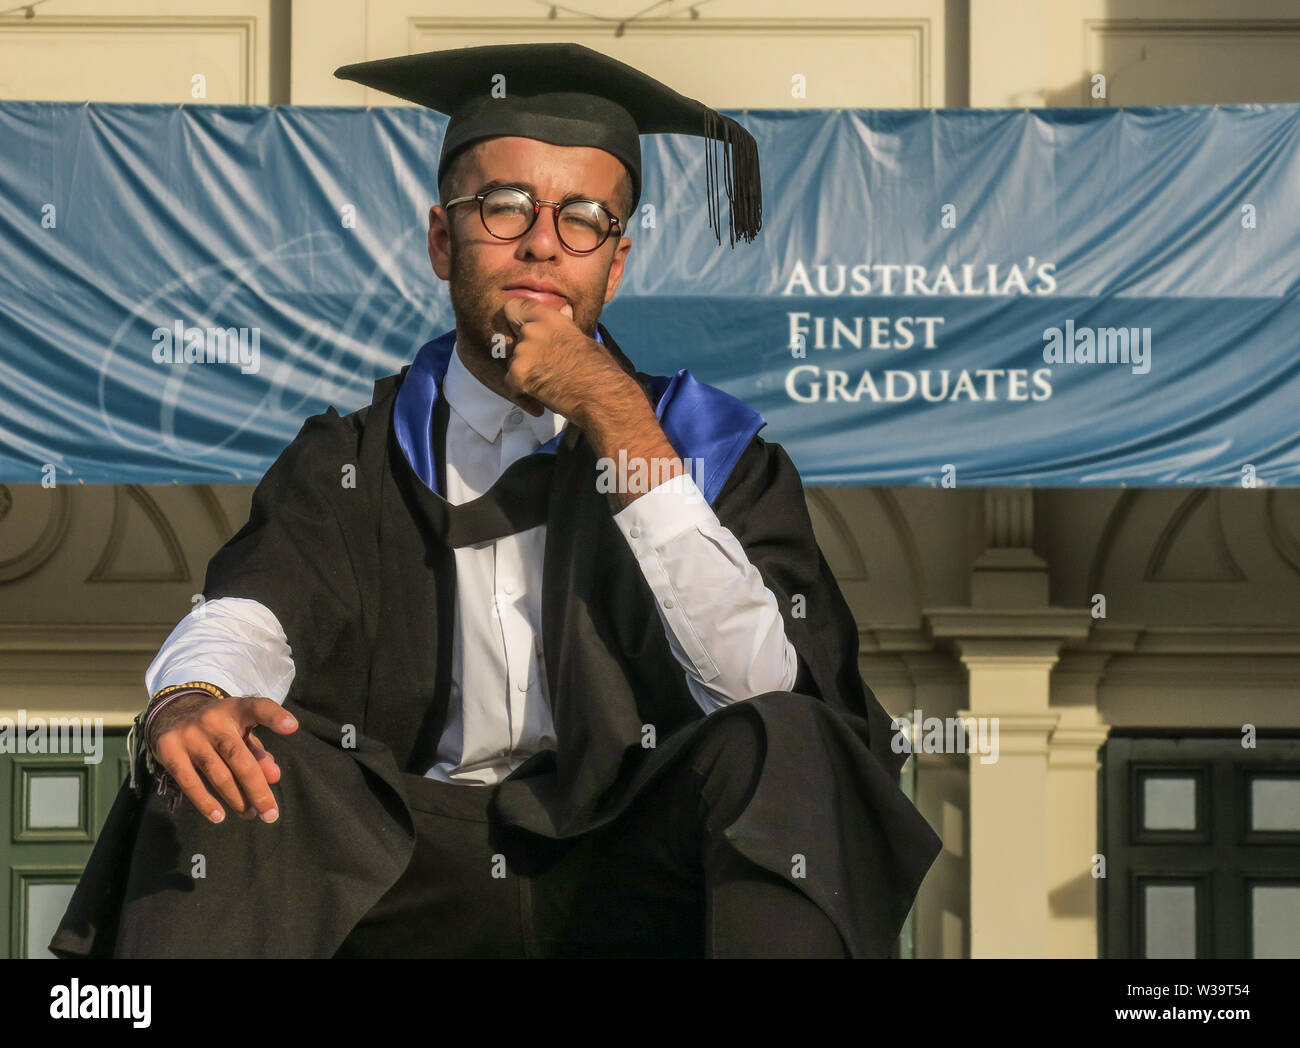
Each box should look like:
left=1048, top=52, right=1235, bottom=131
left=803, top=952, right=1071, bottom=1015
left=334, top=43, right=763, bottom=247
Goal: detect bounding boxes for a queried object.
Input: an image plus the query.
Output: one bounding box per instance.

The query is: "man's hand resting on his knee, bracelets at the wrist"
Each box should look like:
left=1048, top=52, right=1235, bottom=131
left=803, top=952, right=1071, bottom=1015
left=148, top=694, right=298, bottom=823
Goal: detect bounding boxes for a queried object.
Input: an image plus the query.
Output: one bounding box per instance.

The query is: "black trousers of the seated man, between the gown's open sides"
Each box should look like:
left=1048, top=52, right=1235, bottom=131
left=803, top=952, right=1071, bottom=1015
left=335, top=715, right=848, bottom=958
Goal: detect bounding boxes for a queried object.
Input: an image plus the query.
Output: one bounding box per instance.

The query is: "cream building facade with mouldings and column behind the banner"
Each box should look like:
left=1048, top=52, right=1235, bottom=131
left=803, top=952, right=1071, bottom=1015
left=0, top=0, right=1300, bottom=958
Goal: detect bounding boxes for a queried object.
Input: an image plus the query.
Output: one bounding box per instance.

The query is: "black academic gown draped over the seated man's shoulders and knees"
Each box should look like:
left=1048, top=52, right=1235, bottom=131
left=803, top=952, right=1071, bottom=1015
left=51, top=326, right=941, bottom=957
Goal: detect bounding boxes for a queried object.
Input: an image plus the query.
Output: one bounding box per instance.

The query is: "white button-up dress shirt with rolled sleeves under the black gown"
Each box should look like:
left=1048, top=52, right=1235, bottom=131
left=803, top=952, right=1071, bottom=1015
left=146, top=340, right=798, bottom=785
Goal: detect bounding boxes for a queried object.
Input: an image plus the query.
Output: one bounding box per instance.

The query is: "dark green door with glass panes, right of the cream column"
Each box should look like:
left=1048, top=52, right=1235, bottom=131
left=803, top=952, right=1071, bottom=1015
left=1097, top=728, right=1300, bottom=958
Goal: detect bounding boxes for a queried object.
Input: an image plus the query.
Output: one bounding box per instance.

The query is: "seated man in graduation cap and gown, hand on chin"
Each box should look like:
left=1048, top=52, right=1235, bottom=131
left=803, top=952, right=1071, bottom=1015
left=51, top=44, right=940, bottom=957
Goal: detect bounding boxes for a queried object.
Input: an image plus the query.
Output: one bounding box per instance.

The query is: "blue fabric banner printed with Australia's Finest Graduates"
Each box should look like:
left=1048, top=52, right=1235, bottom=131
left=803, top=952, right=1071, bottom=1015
left=0, top=101, right=1300, bottom=486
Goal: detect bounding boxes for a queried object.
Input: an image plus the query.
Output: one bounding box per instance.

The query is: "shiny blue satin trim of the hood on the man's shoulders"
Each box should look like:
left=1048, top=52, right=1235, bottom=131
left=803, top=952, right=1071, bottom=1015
left=393, top=328, right=767, bottom=504
